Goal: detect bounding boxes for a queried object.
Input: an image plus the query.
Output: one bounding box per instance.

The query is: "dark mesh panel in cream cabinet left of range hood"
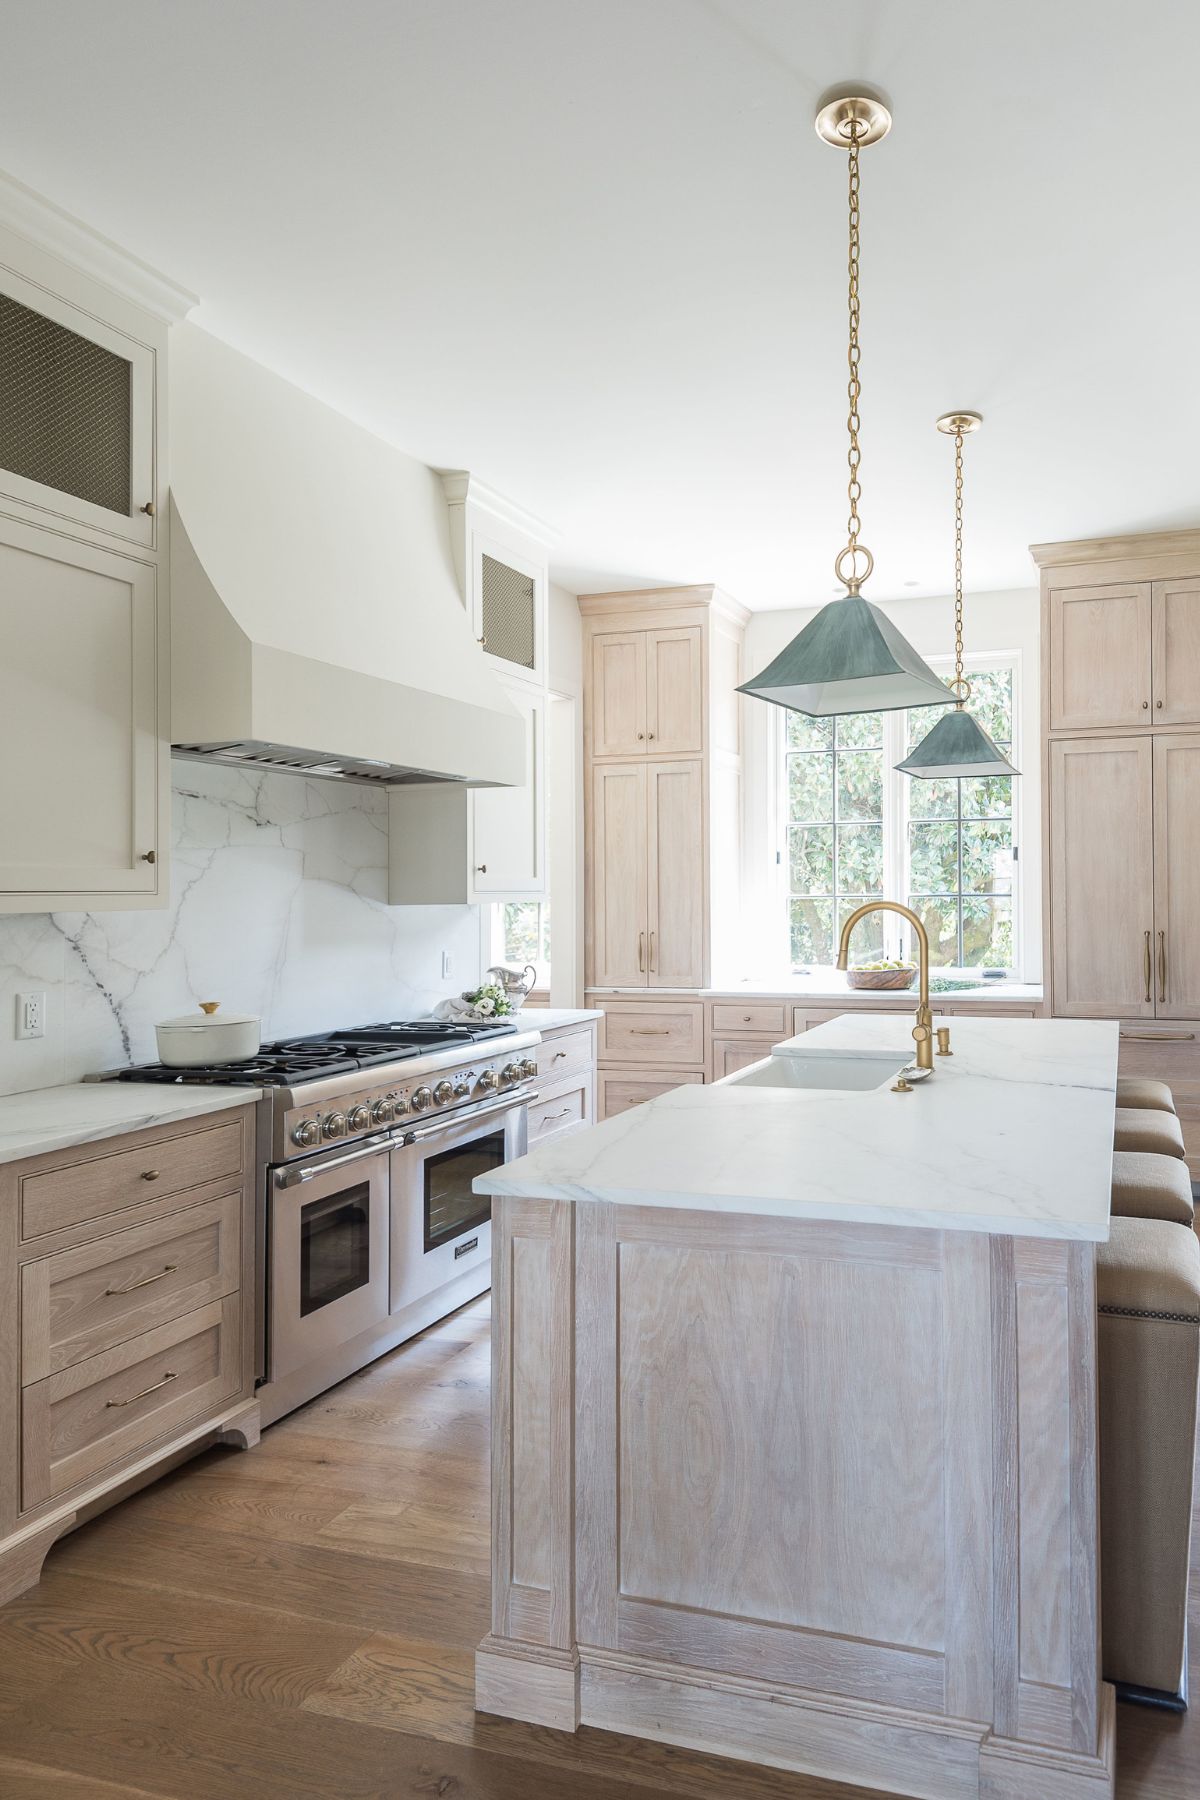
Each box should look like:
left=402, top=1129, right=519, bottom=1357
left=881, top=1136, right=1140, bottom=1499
left=0, top=293, right=133, bottom=518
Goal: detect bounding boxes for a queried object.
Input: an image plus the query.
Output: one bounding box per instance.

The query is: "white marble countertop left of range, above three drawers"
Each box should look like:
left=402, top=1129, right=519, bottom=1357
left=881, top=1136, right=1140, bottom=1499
left=0, top=1082, right=263, bottom=1163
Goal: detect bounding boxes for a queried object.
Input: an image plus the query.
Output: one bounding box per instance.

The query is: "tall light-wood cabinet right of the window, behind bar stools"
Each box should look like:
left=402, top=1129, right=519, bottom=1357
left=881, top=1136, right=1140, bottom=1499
left=1033, top=531, right=1200, bottom=1177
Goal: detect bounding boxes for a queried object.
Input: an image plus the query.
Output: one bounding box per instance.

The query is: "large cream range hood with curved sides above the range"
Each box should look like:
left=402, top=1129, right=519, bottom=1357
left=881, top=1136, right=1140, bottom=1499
left=171, top=326, right=525, bottom=787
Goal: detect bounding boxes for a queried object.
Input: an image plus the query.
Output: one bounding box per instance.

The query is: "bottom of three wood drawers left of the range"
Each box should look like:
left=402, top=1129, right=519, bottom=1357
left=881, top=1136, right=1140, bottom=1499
left=22, top=1294, right=241, bottom=1508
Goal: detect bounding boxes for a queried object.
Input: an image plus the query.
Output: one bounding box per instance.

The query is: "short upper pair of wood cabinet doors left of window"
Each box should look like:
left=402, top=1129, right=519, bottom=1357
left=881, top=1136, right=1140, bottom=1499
left=588, top=625, right=703, bottom=756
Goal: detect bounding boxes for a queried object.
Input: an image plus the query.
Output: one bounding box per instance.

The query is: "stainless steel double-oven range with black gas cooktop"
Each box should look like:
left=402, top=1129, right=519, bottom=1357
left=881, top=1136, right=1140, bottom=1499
left=110, top=1019, right=540, bottom=1424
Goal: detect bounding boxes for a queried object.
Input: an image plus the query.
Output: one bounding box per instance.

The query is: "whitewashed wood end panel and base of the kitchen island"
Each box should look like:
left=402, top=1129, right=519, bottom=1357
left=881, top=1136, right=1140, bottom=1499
left=475, top=1197, right=1114, bottom=1800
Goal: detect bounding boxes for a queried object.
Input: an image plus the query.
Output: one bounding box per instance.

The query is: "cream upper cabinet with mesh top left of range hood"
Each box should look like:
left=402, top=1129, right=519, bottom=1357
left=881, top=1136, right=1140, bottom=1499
left=0, top=176, right=194, bottom=913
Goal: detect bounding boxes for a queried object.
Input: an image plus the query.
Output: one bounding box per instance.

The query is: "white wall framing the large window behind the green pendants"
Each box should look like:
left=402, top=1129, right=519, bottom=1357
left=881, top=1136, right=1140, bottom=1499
left=741, top=589, right=1042, bottom=981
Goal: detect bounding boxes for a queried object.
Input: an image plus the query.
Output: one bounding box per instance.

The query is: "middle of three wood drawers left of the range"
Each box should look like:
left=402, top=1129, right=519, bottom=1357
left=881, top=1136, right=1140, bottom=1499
left=22, top=1193, right=241, bottom=1386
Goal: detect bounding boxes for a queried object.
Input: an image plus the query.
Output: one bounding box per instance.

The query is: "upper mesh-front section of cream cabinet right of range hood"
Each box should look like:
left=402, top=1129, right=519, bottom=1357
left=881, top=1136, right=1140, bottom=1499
left=443, top=472, right=551, bottom=688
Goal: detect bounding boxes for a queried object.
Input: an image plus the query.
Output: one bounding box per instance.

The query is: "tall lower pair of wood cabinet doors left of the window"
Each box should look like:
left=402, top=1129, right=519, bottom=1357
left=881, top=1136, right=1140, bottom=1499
left=592, top=761, right=703, bottom=988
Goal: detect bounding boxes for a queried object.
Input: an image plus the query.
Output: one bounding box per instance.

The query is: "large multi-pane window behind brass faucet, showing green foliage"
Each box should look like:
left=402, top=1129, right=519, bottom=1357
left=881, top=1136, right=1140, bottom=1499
left=777, top=659, right=1018, bottom=970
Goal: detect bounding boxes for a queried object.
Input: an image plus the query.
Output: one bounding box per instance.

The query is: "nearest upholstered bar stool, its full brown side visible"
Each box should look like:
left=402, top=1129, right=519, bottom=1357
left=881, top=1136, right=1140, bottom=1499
left=1096, top=1219, right=1200, bottom=1708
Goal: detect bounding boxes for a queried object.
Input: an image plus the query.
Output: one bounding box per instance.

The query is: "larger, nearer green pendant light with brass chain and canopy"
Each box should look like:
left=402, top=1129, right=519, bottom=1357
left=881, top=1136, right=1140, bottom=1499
left=738, top=94, right=946, bottom=718
